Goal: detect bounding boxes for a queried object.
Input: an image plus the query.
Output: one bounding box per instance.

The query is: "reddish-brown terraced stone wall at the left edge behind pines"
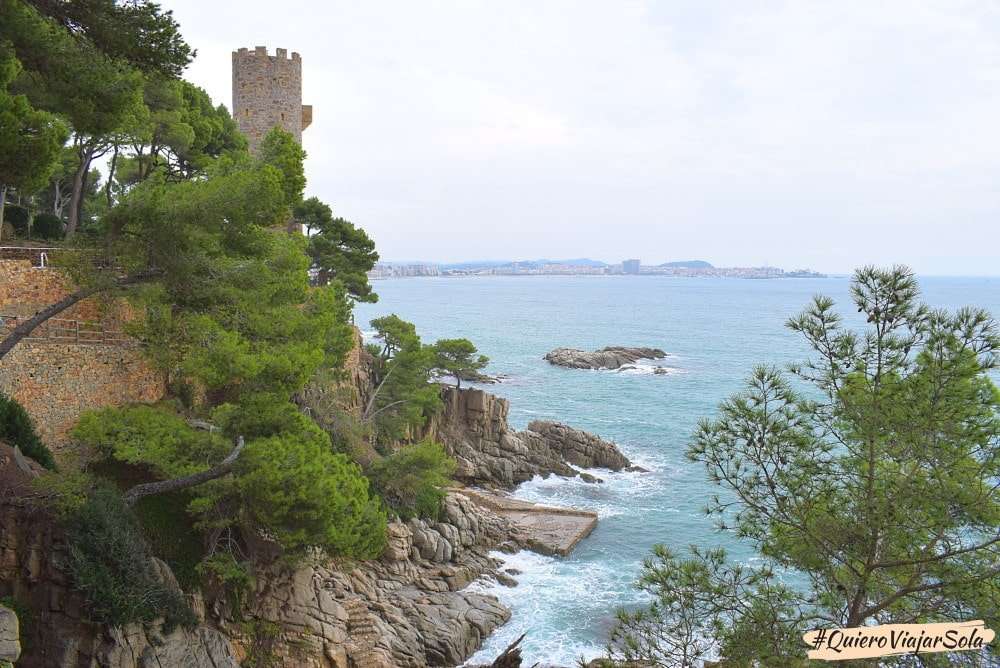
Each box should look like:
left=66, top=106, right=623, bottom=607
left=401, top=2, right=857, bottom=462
left=0, top=260, right=166, bottom=457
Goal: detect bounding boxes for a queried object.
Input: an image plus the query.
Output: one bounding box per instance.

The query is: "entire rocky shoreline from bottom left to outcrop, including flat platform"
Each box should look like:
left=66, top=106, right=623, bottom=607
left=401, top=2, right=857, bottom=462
left=0, top=388, right=641, bottom=668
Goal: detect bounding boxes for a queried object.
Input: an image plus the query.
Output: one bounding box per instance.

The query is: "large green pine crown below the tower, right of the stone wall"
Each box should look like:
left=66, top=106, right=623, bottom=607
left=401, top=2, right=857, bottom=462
left=109, top=163, right=353, bottom=398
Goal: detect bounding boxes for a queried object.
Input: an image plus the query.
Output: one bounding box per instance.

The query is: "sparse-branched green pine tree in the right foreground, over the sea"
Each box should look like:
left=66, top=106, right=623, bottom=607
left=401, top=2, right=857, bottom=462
left=613, top=268, right=1000, bottom=665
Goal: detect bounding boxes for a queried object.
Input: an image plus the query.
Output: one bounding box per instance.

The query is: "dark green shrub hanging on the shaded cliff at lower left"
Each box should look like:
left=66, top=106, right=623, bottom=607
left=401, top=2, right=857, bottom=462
left=64, top=488, right=197, bottom=627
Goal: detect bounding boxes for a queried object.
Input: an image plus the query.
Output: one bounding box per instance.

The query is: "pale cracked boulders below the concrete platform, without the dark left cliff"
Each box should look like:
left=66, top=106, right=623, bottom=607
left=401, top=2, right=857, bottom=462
left=216, top=495, right=517, bottom=668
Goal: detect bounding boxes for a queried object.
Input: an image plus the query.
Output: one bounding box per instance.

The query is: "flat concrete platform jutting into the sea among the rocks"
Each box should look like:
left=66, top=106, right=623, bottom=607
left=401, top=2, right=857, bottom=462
left=451, top=488, right=597, bottom=557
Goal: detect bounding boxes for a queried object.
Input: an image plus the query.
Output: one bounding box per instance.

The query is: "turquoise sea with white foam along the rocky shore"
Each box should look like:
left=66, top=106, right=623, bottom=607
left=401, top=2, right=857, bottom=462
left=356, top=276, right=1000, bottom=665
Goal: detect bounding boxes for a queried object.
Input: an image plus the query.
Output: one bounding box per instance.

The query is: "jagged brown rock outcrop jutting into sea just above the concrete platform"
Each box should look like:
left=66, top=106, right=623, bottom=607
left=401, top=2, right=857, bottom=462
left=428, top=388, right=631, bottom=489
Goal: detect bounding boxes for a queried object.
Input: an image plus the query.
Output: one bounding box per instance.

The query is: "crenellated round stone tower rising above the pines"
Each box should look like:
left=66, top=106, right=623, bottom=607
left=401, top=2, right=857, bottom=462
left=233, top=46, right=312, bottom=153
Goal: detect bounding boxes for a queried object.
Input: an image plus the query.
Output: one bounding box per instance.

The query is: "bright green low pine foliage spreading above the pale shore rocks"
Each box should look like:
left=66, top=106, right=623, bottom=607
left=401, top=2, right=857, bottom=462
left=73, top=395, right=385, bottom=558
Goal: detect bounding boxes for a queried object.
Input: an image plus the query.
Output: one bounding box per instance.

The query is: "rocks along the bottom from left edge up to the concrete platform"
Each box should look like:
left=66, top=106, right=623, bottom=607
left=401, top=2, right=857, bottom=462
left=0, top=474, right=527, bottom=668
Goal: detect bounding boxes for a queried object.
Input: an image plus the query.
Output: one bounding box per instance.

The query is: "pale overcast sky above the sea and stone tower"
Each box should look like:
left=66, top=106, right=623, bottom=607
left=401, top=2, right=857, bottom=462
left=163, top=0, right=1000, bottom=275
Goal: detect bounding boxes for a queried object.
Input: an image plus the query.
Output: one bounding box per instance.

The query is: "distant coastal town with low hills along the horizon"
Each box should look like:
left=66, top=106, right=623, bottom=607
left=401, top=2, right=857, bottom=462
left=368, top=258, right=827, bottom=280
